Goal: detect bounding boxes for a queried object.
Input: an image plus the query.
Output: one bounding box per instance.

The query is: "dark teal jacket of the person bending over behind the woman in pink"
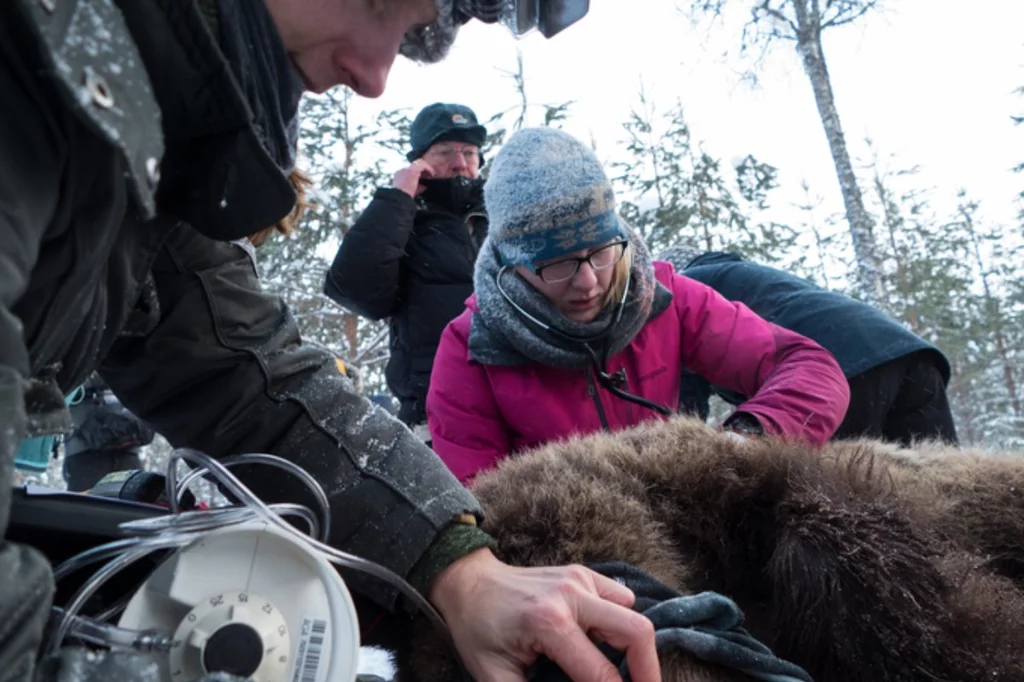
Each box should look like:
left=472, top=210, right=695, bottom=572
left=680, top=251, right=950, bottom=416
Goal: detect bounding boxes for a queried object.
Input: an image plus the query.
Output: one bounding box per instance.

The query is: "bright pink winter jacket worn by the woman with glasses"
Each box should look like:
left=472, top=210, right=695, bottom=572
left=427, top=262, right=850, bottom=482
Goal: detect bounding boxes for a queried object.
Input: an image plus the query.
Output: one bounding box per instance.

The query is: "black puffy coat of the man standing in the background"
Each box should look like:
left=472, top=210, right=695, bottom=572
left=325, top=180, right=487, bottom=424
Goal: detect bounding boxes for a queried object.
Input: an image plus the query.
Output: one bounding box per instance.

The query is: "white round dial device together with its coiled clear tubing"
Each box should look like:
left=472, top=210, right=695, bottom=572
left=44, top=449, right=451, bottom=682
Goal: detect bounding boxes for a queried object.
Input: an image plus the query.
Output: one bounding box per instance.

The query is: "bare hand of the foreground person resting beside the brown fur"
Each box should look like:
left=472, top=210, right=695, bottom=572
left=430, top=550, right=662, bottom=682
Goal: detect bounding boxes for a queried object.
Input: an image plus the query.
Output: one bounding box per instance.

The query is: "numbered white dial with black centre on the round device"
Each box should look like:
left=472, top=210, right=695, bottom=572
left=170, top=592, right=292, bottom=682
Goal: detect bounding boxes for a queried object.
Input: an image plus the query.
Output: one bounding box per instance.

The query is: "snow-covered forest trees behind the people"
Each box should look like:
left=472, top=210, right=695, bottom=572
left=258, top=0, right=1024, bottom=447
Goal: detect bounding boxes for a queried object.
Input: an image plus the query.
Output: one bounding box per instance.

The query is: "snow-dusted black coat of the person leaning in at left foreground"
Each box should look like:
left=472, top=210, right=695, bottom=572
left=0, top=0, right=479, bottom=630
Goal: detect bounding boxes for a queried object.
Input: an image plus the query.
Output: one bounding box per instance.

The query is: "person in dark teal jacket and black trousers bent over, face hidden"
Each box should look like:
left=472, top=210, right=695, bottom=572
left=660, top=248, right=957, bottom=445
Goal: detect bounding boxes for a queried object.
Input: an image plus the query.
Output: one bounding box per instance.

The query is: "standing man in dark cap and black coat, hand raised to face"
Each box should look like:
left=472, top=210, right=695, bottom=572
left=325, top=102, right=487, bottom=441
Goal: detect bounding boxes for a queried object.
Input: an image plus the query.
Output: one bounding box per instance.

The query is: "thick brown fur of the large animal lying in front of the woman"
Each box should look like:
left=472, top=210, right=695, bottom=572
left=399, top=418, right=1024, bottom=682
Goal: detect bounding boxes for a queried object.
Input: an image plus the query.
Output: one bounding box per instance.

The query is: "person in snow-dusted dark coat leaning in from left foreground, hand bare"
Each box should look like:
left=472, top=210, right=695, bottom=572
left=0, top=0, right=658, bottom=682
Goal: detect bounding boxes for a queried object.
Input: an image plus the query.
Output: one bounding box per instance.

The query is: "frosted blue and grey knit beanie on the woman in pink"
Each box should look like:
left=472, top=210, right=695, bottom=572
left=483, top=128, right=628, bottom=266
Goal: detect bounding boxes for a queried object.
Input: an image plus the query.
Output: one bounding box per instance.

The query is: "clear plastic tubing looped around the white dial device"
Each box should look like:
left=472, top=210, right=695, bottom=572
left=46, top=449, right=452, bottom=655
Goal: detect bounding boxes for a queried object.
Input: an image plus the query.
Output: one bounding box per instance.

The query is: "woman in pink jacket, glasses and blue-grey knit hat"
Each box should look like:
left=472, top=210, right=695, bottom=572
left=427, top=128, right=849, bottom=482
